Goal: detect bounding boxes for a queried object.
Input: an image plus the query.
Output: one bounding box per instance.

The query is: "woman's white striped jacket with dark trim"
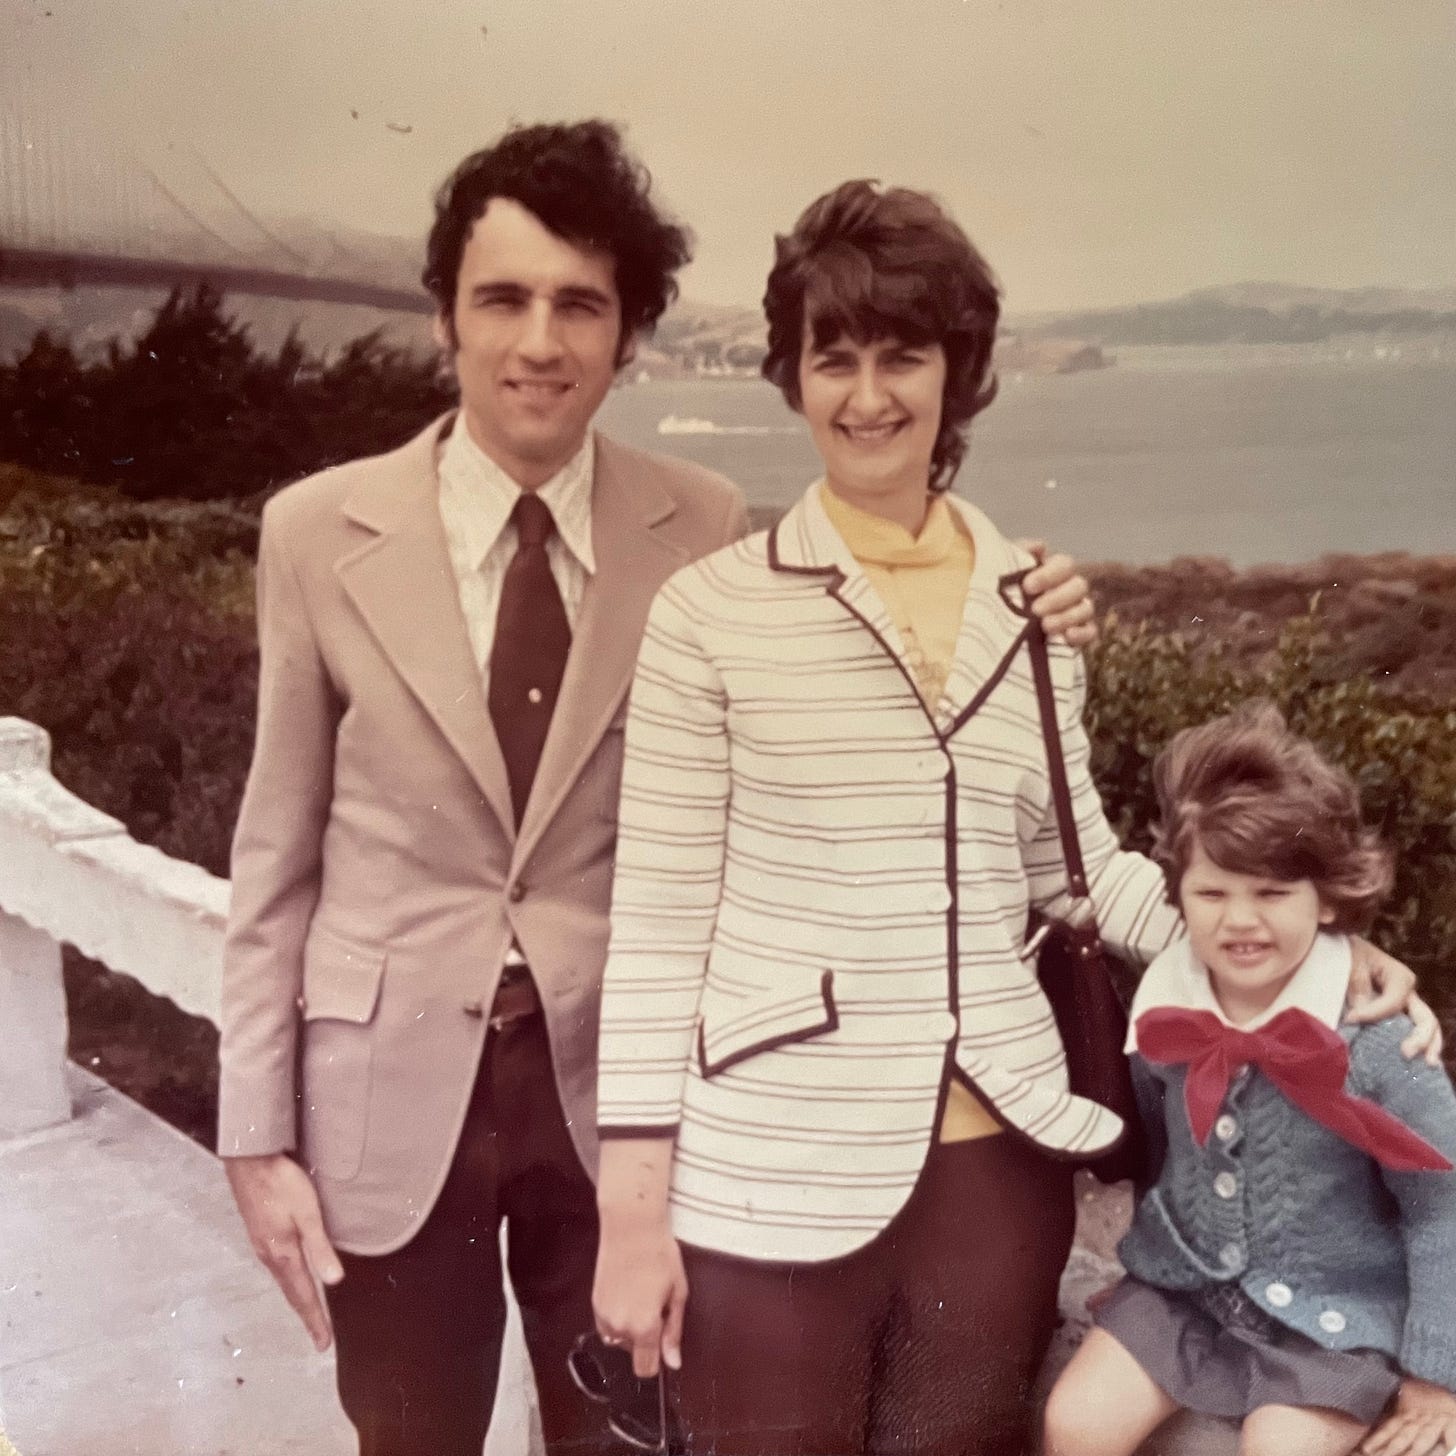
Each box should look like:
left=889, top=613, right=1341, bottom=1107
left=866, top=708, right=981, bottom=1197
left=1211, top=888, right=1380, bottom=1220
left=598, top=489, right=1178, bottom=1261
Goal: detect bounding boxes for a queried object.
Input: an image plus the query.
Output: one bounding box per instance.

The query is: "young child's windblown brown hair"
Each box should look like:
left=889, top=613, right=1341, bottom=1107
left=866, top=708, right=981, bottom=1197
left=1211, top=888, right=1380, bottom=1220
left=1153, top=702, right=1392, bottom=930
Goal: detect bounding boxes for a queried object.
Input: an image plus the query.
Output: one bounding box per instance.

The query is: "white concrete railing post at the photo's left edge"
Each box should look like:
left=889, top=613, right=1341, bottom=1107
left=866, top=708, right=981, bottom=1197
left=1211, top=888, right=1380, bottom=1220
left=0, top=718, right=71, bottom=1137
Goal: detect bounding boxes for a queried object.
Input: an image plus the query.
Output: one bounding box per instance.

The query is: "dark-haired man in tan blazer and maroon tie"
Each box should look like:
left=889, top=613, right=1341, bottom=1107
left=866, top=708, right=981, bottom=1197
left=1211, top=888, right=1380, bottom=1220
left=220, top=121, right=1091, bottom=1456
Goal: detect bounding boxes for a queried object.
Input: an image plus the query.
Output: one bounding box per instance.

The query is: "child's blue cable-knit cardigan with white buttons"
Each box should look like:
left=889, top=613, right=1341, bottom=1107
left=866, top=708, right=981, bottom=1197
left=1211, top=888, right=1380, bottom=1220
left=1118, top=1016, right=1456, bottom=1390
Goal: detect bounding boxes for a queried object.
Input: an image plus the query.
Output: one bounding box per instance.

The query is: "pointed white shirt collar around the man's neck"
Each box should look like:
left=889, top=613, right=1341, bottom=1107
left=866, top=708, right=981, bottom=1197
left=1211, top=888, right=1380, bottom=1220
left=440, top=409, right=597, bottom=575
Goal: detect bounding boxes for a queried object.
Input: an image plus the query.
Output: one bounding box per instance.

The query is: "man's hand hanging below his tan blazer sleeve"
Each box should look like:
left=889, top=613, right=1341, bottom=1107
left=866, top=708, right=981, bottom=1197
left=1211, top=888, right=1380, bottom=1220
left=223, top=1153, right=344, bottom=1350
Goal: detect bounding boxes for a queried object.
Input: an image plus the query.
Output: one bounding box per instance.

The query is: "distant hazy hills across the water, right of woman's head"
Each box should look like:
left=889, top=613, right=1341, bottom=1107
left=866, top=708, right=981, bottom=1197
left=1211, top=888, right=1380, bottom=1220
left=1019, top=282, right=1456, bottom=347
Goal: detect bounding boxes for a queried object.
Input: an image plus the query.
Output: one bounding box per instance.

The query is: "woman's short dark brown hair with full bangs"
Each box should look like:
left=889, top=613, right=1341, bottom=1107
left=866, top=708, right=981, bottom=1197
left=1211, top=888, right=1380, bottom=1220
left=763, top=182, right=1000, bottom=491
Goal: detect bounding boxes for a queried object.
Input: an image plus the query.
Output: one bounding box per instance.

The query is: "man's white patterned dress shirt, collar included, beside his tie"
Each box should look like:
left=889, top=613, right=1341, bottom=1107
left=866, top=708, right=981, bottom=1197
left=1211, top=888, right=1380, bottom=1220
left=440, top=411, right=597, bottom=692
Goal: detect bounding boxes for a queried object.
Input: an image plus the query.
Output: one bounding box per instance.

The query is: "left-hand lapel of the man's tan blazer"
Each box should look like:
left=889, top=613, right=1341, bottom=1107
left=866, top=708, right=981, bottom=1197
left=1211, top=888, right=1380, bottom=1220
left=335, top=421, right=515, bottom=840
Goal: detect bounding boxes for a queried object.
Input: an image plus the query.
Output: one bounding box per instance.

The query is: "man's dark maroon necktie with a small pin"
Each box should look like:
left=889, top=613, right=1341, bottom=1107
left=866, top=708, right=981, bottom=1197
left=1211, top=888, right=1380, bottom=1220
left=486, top=491, right=571, bottom=826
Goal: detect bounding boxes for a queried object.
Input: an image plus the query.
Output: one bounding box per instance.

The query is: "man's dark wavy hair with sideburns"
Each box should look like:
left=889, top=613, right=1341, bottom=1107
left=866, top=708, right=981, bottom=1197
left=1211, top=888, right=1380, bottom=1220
left=421, top=119, right=692, bottom=352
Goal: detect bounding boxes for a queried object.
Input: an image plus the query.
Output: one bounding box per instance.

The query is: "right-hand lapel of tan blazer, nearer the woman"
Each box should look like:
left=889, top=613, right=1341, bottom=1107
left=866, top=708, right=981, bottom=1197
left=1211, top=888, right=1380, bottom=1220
left=515, top=435, right=690, bottom=868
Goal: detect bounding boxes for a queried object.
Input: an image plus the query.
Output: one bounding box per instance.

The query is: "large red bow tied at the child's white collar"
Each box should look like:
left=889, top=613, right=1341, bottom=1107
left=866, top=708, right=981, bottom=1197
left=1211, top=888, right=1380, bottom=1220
left=1137, top=1006, right=1452, bottom=1172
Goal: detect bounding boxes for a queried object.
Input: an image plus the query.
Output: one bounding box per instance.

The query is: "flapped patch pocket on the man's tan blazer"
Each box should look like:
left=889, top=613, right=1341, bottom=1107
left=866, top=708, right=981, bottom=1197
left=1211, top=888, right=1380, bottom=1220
left=300, top=929, right=386, bottom=1179
